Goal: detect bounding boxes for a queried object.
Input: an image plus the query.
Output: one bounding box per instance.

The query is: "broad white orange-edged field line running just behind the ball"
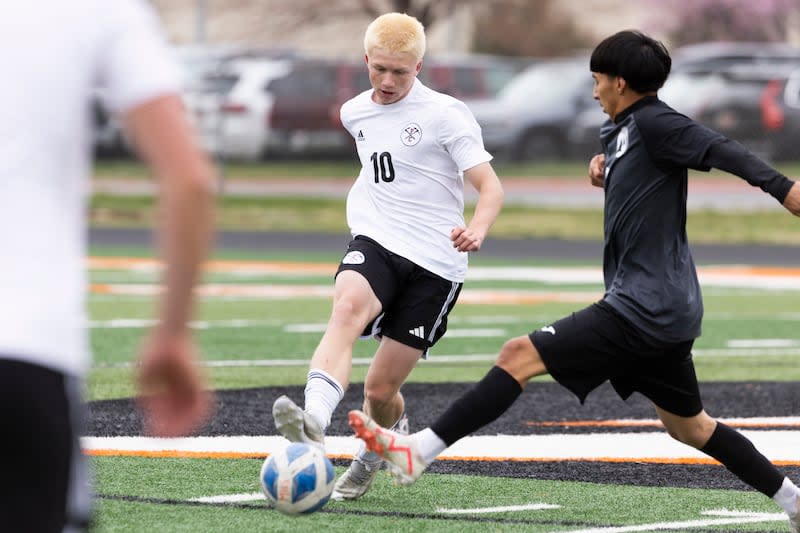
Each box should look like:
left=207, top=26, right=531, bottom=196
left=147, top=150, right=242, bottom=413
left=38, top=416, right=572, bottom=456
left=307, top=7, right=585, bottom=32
left=81, top=429, right=800, bottom=464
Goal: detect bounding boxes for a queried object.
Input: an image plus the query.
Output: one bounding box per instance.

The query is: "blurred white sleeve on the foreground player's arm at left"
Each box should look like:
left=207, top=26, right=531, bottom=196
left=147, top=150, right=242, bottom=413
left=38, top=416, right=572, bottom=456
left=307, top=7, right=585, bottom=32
left=98, top=0, right=181, bottom=113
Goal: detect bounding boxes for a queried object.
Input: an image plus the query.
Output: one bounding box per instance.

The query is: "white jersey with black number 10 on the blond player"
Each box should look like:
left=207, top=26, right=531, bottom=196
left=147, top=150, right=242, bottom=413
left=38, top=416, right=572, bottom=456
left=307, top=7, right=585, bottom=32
left=341, top=80, right=492, bottom=282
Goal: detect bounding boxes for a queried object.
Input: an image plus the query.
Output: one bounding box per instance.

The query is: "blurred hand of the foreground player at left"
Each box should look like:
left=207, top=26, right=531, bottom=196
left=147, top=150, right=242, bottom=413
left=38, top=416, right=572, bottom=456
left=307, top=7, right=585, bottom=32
left=138, top=328, right=213, bottom=437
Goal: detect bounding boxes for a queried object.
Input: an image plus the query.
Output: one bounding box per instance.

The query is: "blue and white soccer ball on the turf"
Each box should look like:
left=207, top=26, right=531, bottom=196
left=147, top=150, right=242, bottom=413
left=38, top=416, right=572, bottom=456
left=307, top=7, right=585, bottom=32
left=261, top=442, right=335, bottom=515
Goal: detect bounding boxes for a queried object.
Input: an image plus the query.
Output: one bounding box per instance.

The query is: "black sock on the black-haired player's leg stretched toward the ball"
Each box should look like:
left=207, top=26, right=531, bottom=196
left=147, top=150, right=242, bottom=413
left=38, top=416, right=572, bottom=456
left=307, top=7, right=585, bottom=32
left=431, top=366, right=522, bottom=446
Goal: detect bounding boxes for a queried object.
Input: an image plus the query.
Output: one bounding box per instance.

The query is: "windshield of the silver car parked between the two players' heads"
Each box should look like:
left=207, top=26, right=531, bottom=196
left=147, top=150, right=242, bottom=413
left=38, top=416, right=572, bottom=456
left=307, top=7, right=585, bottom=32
left=497, top=63, right=591, bottom=107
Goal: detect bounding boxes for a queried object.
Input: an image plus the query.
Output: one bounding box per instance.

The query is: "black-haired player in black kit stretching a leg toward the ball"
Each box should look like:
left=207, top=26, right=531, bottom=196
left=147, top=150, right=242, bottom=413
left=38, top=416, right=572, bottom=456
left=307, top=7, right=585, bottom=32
left=349, top=31, right=800, bottom=531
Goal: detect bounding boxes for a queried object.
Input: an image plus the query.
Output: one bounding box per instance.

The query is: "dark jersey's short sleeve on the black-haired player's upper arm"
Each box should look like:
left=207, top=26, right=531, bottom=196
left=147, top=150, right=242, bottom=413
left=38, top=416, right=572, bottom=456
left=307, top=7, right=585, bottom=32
left=636, top=108, right=725, bottom=171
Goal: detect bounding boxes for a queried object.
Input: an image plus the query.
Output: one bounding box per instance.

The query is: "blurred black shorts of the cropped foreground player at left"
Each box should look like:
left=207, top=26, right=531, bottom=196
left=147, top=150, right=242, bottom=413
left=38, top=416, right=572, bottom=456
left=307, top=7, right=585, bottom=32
left=0, top=357, right=91, bottom=532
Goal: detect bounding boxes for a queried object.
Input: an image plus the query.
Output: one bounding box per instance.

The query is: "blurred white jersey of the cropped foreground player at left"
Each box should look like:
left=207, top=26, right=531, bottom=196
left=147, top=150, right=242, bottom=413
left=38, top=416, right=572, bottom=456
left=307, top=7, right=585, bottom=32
left=0, top=0, right=180, bottom=375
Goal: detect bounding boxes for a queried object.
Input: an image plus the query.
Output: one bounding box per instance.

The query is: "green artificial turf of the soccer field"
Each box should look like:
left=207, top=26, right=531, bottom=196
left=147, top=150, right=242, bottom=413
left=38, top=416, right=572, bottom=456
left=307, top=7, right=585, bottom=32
left=88, top=250, right=800, bottom=532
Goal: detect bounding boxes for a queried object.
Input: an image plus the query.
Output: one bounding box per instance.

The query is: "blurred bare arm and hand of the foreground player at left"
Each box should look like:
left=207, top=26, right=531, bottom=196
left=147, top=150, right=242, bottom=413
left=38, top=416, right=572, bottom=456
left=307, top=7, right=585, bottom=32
left=125, top=95, right=213, bottom=437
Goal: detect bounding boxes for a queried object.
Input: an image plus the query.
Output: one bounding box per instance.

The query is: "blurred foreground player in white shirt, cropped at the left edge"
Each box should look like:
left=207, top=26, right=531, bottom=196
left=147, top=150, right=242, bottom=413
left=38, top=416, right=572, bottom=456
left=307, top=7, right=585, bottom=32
left=0, top=0, right=213, bottom=532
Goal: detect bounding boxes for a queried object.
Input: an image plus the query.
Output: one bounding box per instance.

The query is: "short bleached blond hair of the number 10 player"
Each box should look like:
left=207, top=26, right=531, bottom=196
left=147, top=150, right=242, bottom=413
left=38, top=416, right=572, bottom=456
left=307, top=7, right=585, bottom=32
left=364, top=13, right=425, bottom=60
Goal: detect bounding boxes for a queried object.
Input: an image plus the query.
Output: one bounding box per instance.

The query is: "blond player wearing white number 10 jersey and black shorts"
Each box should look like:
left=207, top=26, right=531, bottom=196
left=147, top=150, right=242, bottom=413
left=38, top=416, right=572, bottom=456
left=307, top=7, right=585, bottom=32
left=273, top=13, right=503, bottom=500
